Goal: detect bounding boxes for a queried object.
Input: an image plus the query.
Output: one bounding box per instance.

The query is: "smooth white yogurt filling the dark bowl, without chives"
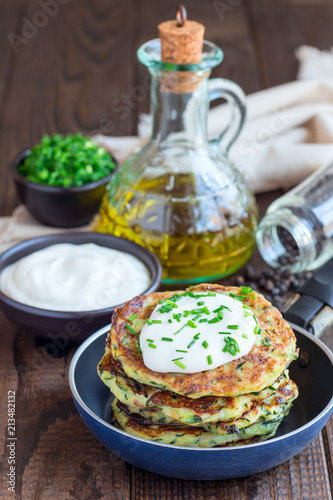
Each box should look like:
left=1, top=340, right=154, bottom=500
left=0, top=243, right=150, bottom=311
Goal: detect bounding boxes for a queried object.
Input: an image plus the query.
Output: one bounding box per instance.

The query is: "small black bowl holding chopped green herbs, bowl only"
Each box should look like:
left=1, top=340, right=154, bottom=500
left=12, top=149, right=117, bottom=227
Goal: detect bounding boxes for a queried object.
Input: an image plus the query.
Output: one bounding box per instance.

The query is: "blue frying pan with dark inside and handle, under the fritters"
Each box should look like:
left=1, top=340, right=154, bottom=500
left=69, top=260, right=333, bottom=479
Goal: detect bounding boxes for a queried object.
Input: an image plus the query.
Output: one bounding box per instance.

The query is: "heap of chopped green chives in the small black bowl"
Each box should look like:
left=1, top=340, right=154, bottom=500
left=18, top=134, right=115, bottom=187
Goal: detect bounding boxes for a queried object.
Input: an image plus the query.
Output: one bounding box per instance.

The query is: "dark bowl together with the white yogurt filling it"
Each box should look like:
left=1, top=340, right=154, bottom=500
left=0, top=232, right=162, bottom=342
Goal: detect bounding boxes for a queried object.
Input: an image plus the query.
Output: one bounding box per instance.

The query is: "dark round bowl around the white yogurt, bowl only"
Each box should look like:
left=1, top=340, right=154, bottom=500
left=0, top=232, right=162, bottom=342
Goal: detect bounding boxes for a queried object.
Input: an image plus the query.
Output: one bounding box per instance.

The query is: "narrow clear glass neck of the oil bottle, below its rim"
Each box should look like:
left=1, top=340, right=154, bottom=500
left=151, top=71, right=209, bottom=148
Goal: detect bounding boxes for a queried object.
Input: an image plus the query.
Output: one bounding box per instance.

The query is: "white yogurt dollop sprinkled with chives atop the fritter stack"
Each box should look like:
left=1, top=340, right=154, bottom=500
left=140, top=292, right=260, bottom=373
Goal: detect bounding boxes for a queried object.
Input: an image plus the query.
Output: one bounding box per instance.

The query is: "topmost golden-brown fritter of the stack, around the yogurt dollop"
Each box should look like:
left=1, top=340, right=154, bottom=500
left=104, top=284, right=296, bottom=398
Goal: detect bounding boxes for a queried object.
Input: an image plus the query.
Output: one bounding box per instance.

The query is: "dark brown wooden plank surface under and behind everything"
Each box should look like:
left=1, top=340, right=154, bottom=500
left=0, top=0, right=333, bottom=500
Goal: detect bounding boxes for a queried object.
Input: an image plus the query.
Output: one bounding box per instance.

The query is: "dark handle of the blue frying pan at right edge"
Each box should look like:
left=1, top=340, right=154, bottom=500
left=284, top=259, right=333, bottom=337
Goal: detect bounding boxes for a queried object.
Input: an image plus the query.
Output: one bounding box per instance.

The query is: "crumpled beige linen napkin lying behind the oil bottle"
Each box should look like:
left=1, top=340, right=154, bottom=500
left=0, top=46, right=333, bottom=252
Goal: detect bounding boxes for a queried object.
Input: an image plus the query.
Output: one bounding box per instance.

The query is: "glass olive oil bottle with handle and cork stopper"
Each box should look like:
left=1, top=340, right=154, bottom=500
left=97, top=6, right=257, bottom=284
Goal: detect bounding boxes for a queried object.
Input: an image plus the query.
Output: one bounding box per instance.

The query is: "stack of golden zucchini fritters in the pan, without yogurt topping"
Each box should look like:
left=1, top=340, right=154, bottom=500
left=98, top=284, right=298, bottom=448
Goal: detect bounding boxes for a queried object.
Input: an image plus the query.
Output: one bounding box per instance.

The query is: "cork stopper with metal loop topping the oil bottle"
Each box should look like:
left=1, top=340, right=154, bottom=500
left=158, top=5, right=205, bottom=64
